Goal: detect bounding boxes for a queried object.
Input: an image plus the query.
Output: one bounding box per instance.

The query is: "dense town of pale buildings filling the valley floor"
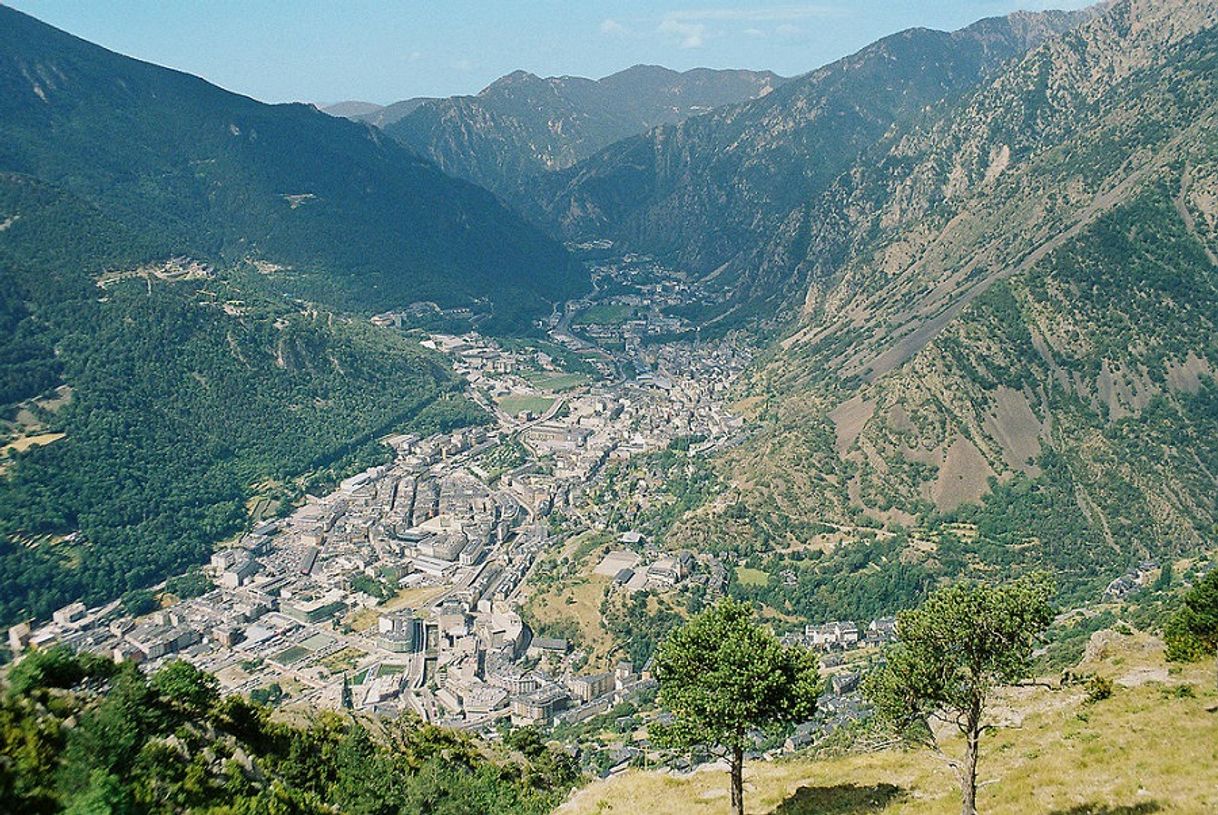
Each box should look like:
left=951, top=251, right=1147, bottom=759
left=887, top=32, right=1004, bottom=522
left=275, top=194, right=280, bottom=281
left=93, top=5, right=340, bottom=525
left=10, top=256, right=750, bottom=774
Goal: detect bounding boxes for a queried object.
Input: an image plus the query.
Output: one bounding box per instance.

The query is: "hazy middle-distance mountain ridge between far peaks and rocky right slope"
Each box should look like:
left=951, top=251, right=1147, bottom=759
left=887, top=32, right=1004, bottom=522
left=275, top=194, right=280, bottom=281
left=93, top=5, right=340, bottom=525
left=533, top=12, right=1091, bottom=311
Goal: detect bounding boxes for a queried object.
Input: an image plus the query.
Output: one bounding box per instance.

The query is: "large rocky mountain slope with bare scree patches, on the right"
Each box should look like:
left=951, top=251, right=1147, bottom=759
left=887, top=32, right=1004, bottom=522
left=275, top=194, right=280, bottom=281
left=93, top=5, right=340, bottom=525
left=662, top=0, right=1218, bottom=604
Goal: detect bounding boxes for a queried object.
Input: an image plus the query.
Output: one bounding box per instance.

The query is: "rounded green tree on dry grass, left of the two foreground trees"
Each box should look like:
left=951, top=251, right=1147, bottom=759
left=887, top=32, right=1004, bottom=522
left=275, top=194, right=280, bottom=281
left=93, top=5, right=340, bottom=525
left=653, top=597, right=821, bottom=815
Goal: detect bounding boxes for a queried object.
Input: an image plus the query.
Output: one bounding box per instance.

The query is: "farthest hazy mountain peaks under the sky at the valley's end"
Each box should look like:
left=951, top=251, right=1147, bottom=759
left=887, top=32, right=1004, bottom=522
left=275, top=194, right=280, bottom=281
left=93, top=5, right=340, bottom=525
left=385, top=65, right=784, bottom=200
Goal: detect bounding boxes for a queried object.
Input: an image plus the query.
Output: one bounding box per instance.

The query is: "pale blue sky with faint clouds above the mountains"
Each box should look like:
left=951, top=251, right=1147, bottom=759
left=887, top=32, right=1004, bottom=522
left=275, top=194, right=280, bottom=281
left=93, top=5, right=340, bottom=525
left=7, top=0, right=1088, bottom=104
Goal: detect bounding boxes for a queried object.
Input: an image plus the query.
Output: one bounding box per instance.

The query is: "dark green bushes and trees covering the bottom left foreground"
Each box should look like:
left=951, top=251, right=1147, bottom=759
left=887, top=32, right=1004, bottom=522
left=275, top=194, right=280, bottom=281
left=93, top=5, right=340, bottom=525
left=0, top=649, right=576, bottom=815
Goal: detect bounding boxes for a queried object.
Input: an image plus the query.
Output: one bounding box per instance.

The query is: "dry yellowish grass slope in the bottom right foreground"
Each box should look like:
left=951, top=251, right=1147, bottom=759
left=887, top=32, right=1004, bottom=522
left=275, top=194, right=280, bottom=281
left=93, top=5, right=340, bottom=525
left=559, top=637, right=1218, bottom=815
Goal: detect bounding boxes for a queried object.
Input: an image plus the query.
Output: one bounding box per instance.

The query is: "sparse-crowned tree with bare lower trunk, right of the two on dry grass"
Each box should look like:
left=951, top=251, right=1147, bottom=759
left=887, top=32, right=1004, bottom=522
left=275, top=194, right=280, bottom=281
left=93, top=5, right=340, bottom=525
left=864, top=576, right=1055, bottom=815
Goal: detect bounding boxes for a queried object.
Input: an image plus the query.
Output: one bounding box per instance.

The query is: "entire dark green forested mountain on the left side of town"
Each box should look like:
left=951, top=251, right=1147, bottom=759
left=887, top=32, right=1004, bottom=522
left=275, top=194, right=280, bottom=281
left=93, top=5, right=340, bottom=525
left=0, top=7, right=582, bottom=623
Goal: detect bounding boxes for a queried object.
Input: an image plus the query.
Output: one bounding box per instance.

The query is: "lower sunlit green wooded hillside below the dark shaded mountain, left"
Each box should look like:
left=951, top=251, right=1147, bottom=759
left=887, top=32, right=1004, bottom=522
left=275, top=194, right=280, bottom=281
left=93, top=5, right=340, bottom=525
left=0, top=170, right=485, bottom=620
